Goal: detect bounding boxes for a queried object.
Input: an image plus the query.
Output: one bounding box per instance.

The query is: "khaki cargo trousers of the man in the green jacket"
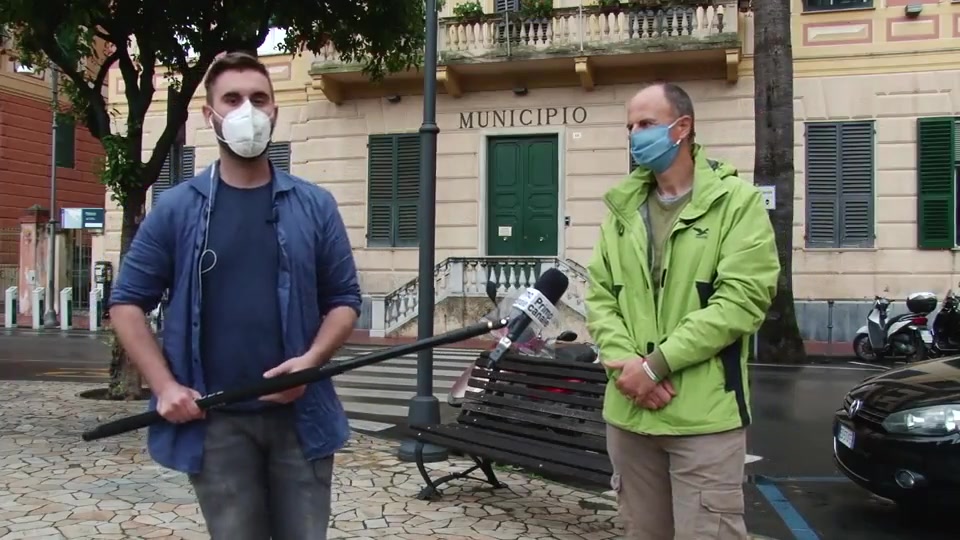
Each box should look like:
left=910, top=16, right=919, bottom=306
left=607, top=425, right=750, bottom=540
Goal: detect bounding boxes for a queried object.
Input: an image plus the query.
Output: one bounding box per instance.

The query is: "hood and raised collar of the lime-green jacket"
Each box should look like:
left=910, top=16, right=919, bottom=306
left=603, top=144, right=739, bottom=220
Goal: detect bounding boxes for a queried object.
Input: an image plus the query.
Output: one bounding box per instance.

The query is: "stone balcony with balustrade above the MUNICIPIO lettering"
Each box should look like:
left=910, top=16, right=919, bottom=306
left=311, top=0, right=752, bottom=103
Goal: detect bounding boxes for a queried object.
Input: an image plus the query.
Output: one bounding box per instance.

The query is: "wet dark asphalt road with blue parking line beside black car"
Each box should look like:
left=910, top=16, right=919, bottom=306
left=0, top=330, right=958, bottom=540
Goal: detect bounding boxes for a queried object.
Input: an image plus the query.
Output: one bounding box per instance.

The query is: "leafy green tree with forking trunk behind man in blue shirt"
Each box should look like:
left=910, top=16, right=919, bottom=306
left=0, top=0, right=425, bottom=399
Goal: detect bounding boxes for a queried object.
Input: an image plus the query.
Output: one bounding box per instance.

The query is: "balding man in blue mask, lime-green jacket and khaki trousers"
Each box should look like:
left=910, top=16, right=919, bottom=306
left=586, top=84, right=780, bottom=540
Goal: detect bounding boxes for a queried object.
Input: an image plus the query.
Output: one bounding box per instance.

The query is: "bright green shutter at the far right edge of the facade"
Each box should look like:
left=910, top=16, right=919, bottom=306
left=917, top=117, right=957, bottom=249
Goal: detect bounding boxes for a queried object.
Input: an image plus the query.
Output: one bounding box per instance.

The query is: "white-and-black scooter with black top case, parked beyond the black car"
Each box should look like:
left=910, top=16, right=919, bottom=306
left=853, top=292, right=937, bottom=362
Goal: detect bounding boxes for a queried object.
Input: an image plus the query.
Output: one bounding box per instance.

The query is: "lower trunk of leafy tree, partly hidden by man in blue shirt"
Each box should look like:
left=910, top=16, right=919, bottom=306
left=109, top=188, right=147, bottom=400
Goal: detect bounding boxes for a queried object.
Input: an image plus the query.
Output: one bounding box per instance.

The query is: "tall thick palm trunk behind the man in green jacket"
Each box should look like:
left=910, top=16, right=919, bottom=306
left=753, top=2, right=806, bottom=363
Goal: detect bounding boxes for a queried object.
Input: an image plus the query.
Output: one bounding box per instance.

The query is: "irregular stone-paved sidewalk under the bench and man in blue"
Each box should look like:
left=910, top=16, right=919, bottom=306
left=0, top=382, right=622, bottom=540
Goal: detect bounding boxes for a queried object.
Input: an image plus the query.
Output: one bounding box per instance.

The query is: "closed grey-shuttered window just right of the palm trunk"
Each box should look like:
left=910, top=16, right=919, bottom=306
left=806, top=121, right=874, bottom=248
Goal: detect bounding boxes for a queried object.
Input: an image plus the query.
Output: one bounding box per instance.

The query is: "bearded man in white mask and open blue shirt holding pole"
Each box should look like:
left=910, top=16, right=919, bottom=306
left=110, top=53, right=360, bottom=540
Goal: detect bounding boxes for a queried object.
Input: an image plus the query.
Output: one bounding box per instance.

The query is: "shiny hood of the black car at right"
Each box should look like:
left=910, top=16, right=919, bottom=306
left=849, top=356, right=960, bottom=413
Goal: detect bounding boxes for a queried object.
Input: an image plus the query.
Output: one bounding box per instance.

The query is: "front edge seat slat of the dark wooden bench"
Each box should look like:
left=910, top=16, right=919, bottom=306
left=419, top=425, right=613, bottom=474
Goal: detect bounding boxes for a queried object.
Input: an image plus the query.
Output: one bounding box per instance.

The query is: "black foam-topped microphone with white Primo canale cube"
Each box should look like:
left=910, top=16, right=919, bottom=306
left=489, top=268, right=570, bottom=362
